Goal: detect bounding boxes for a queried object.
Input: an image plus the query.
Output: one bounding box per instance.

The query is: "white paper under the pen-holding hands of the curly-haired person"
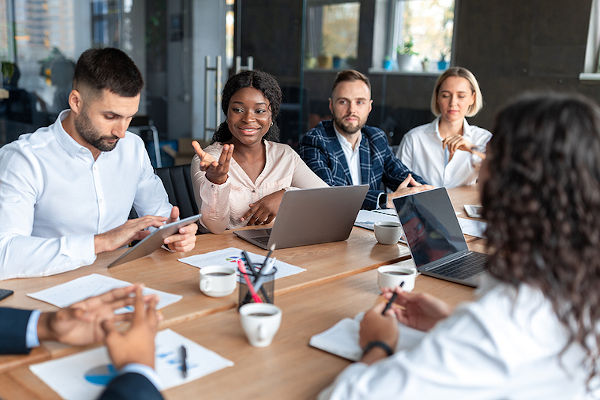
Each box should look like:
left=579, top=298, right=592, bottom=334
left=309, top=313, right=425, bottom=361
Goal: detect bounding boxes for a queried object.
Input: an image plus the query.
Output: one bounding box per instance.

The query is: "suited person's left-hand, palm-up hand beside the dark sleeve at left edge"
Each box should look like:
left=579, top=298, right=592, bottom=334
left=38, top=285, right=156, bottom=346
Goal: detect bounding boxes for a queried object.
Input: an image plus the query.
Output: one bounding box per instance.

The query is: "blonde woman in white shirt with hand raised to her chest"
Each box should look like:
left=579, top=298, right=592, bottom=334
left=396, top=67, right=492, bottom=188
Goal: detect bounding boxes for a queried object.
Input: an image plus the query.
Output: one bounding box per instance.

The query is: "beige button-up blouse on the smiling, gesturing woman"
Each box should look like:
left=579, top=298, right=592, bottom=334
left=192, top=140, right=327, bottom=233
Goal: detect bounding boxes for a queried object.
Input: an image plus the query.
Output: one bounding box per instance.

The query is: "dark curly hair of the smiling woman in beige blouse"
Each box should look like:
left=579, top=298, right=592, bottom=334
left=213, top=71, right=282, bottom=143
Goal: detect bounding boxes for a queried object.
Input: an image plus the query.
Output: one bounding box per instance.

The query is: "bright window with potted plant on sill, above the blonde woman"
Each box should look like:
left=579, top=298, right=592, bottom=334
left=373, top=0, right=454, bottom=73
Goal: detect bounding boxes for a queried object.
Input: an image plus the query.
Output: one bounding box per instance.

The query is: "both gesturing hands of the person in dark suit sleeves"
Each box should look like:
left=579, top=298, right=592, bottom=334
left=37, top=285, right=162, bottom=368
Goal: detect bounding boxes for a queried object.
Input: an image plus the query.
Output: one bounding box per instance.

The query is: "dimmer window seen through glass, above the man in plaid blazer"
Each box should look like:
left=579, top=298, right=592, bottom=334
left=305, top=1, right=360, bottom=69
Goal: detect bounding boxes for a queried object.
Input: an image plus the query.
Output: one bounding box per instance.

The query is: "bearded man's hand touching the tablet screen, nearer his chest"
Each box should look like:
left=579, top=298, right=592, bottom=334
left=94, top=215, right=167, bottom=254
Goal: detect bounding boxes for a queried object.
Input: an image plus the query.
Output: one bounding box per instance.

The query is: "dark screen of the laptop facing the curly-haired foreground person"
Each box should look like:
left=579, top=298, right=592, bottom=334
left=394, top=188, right=467, bottom=268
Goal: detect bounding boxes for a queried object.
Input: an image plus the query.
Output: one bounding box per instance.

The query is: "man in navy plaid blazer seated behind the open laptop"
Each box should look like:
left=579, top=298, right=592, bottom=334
left=300, top=70, right=432, bottom=210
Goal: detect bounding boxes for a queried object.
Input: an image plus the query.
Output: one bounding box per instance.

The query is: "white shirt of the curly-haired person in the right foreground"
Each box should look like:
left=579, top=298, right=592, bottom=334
left=319, top=277, right=593, bottom=400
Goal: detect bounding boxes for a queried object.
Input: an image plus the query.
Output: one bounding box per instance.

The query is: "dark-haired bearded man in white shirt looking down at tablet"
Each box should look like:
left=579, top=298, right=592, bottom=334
left=0, top=48, right=197, bottom=279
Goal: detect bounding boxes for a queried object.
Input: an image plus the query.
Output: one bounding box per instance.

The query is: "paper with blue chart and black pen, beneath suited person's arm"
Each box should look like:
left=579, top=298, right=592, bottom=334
left=29, top=329, right=233, bottom=399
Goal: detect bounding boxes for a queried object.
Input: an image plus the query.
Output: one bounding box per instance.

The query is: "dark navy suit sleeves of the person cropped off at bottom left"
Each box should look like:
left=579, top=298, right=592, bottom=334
left=0, top=307, right=163, bottom=400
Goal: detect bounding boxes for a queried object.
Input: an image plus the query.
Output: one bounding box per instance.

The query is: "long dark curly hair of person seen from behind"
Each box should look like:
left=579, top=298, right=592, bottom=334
left=481, top=93, right=600, bottom=384
